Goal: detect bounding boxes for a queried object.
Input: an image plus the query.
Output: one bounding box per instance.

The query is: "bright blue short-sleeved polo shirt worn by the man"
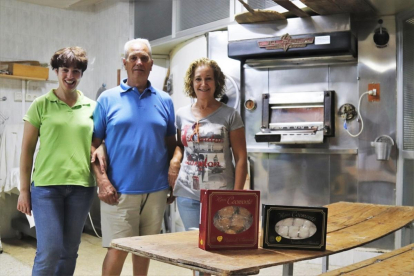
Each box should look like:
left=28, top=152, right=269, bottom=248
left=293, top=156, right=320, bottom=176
left=93, top=79, right=176, bottom=194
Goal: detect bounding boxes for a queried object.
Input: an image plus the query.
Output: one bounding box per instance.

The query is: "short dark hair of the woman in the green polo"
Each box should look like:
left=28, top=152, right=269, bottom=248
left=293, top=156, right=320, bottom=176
left=50, top=46, right=88, bottom=73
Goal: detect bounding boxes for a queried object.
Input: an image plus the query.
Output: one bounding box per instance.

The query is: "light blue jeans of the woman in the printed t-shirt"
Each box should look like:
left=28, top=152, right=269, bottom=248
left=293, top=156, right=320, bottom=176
left=177, top=197, right=200, bottom=231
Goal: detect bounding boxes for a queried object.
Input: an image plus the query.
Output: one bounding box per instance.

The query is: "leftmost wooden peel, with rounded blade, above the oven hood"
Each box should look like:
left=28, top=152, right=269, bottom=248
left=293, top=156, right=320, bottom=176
left=234, top=0, right=286, bottom=24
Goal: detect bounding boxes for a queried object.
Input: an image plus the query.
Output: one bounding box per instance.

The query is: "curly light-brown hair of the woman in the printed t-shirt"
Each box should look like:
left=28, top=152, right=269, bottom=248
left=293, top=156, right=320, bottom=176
left=184, top=58, right=226, bottom=98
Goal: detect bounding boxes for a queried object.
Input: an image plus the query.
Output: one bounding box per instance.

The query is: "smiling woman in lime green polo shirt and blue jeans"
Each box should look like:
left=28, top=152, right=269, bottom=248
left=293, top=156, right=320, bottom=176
left=17, top=47, right=96, bottom=276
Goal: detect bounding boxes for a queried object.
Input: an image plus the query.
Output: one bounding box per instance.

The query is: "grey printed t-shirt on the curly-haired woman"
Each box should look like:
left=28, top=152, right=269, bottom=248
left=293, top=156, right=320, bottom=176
left=174, top=103, right=244, bottom=200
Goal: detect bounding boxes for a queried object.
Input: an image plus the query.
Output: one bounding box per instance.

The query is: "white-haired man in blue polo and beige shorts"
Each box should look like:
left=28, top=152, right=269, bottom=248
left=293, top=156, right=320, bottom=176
left=92, top=39, right=176, bottom=275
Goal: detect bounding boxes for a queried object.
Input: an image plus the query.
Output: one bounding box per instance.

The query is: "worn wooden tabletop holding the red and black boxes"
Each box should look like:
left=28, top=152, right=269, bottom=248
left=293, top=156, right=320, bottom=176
left=111, top=202, right=414, bottom=275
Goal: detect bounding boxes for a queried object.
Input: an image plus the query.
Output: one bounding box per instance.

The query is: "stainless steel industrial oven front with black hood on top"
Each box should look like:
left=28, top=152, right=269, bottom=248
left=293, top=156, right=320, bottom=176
left=208, top=14, right=397, bottom=248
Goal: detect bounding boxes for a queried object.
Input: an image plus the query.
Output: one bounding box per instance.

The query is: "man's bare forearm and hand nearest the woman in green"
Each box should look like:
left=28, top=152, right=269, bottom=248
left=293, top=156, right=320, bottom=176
left=91, top=138, right=119, bottom=205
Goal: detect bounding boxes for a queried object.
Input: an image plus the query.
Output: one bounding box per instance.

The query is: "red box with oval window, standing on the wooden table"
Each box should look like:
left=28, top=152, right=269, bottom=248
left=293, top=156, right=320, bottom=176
left=198, top=189, right=260, bottom=250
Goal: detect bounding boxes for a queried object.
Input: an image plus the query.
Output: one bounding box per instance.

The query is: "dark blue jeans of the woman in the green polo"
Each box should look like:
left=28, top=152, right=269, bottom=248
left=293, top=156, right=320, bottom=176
left=31, top=183, right=96, bottom=276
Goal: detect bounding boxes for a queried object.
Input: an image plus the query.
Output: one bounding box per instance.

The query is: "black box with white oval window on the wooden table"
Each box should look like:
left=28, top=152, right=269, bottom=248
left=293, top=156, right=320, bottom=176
left=260, top=204, right=328, bottom=251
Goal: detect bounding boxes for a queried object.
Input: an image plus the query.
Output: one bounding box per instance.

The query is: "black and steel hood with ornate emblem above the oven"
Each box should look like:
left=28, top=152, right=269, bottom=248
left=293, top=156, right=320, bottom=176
left=228, top=14, right=357, bottom=67
